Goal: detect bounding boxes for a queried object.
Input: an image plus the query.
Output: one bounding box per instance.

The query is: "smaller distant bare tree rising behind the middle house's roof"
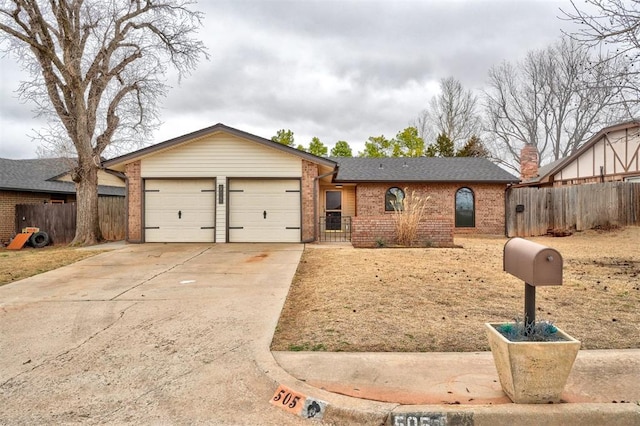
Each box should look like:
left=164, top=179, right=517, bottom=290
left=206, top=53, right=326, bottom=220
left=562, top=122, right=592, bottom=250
left=414, top=77, right=482, bottom=149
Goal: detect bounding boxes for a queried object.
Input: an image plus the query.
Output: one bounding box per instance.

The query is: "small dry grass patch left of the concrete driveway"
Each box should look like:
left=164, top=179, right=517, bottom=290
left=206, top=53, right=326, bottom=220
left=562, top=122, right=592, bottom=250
left=0, top=246, right=99, bottom=286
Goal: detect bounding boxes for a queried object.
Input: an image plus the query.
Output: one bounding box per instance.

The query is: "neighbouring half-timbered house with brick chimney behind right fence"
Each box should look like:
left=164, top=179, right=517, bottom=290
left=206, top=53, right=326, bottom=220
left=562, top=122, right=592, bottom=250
left=518, top=121, right=640, bottom=187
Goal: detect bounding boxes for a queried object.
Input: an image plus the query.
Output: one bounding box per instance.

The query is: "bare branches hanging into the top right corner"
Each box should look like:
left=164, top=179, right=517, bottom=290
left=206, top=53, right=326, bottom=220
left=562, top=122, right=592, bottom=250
left=563, top=0, right=640, bottom=100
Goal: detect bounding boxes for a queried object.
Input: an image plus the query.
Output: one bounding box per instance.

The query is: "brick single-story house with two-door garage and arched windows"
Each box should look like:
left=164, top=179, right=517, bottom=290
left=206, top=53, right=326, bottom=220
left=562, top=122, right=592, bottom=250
left=103, top=124, right=518, bottom=247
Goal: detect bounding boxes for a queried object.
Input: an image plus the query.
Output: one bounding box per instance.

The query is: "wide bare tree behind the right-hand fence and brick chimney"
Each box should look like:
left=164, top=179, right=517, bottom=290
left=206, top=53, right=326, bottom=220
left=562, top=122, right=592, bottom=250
left=485, top=38, right=625, bottom=170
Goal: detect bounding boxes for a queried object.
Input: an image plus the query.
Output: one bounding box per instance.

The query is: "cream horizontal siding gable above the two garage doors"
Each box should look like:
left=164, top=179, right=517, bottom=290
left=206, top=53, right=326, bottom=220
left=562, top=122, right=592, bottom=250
left=141, top=133, right=302, bottom=178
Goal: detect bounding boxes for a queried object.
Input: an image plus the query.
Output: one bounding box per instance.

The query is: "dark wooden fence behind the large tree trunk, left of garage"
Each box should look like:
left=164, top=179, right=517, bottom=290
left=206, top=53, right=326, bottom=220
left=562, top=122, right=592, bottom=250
left=16, top=197, right=125, bottom=244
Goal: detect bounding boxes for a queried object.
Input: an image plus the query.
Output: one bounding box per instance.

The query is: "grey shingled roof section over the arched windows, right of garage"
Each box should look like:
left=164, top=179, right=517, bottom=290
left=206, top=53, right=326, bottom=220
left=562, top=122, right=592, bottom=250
left=331, top=157, right=519, bottom=183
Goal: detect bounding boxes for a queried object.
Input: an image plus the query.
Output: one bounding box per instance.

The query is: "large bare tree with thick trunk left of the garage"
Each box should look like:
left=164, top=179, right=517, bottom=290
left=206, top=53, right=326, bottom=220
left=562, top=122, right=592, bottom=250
left=0, top=0, right=206, bottom=245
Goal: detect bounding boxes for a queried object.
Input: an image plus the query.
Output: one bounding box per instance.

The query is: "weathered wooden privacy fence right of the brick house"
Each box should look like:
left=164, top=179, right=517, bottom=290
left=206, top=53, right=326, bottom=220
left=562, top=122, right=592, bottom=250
left=506, top=182, right=640, bottom=237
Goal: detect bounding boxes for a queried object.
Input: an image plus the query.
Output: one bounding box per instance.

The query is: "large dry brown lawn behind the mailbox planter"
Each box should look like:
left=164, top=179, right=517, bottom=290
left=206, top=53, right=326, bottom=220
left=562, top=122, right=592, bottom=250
left=272, top=227, right=640, bottom=352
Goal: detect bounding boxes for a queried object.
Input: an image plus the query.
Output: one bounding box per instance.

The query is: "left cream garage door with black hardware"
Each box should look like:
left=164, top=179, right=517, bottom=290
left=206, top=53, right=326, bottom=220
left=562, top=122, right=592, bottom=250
left=144, top=179, right=216, bottom=243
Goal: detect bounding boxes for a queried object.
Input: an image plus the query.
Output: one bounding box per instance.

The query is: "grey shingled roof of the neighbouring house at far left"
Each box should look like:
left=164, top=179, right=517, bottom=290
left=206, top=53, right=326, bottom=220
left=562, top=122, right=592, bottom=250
left=0, top=158, right=125, bottom=196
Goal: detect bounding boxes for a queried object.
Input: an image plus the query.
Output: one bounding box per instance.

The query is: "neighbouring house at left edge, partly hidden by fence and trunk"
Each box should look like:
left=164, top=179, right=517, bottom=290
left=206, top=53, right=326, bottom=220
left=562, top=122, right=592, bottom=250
left=0, top=158, right=125, bottom=243
